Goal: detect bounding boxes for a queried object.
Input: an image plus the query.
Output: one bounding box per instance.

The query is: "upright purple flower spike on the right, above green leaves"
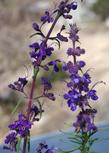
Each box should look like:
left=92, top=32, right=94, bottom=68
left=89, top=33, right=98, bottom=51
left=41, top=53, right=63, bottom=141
left=63, top=22, right=98, bottom=132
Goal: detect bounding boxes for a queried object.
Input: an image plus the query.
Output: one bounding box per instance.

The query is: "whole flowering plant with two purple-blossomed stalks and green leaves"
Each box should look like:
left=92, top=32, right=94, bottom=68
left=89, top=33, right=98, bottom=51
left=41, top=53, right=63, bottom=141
left=2, top=0, right=108, bottom=153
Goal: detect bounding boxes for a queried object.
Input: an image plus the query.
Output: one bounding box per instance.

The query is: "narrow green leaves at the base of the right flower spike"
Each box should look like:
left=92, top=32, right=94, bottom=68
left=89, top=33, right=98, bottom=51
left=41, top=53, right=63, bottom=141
left=59, top=131, right=99, bottom=153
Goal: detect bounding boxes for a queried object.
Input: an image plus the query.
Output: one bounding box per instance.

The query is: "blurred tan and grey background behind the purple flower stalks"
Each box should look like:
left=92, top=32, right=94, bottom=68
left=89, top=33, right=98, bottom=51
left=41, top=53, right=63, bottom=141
left=0, top=0, right=109, bottom=142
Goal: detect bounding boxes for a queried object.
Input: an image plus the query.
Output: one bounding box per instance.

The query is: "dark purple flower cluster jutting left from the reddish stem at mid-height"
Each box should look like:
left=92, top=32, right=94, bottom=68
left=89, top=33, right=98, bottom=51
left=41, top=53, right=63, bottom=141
left=8, top=77, right=28, bottom=92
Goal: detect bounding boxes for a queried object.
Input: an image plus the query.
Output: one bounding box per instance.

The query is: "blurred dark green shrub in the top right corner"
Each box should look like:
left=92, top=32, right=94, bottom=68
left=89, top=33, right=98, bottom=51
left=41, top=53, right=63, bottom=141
left=91, top=0, right=109, bottom=21
